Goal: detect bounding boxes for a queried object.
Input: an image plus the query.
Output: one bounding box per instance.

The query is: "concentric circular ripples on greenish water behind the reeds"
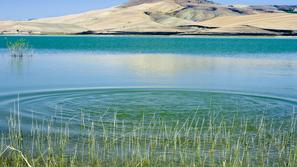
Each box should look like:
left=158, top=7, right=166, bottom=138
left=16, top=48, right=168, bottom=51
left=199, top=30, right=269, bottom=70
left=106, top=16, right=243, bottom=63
left=0, top=88, right=296, bottom=132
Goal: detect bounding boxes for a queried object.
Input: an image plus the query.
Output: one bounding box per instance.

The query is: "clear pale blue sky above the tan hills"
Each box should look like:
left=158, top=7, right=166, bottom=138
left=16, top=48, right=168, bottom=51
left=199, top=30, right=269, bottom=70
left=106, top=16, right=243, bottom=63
left=0, top=0, right=297, bottom=20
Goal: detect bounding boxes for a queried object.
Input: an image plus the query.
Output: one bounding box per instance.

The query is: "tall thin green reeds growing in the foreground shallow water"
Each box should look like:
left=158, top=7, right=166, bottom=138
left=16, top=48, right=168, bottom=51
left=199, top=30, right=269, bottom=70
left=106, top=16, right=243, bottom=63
left=0, top=104, right=297, bottom=167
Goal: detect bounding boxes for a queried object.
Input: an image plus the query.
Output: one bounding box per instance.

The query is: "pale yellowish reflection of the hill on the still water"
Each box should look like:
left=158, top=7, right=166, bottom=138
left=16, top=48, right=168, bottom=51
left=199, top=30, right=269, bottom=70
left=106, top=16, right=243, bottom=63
left=115, top=55, right=297, bottom=75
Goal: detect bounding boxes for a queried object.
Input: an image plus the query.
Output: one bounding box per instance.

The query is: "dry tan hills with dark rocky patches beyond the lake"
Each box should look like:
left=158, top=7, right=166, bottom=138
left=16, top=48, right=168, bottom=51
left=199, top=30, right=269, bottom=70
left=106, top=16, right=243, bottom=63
left=0, top=0, right=297, bottom=35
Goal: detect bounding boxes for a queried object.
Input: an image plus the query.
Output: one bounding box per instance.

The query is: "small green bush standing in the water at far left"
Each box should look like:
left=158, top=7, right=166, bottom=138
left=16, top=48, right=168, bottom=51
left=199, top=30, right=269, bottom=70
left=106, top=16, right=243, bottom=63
left=7, top=39, right=33, bottom=58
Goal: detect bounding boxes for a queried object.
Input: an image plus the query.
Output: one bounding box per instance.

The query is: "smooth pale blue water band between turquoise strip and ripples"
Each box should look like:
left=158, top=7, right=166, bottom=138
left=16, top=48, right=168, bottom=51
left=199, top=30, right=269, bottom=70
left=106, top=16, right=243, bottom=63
left=0, top=52, right=297, bottom=97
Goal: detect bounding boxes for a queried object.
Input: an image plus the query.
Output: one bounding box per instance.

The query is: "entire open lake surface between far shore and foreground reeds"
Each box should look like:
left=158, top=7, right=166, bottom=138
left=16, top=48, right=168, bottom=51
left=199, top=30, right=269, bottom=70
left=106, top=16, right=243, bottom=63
left=0, top=36, right=297, bottom=130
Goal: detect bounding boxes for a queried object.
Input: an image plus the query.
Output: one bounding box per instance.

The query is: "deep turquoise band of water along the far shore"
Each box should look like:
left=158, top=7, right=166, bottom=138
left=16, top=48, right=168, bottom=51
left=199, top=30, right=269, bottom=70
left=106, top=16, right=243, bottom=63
left=0, top=36, right=297, bottom=56
